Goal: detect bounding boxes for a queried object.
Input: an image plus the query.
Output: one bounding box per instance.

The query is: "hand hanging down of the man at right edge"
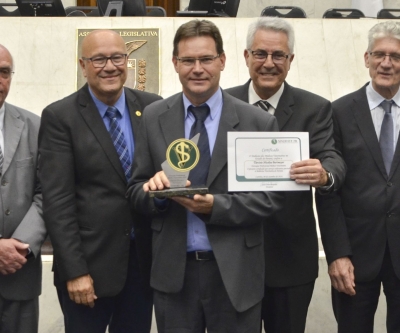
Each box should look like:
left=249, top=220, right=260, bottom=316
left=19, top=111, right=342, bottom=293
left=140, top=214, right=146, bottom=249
left=328, top=257, right=356, bottom=296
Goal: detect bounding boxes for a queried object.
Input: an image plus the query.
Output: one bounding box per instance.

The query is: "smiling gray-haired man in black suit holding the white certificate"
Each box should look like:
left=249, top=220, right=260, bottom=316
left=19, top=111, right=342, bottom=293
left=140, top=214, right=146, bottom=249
left=226, top=17, right=345, bottom=333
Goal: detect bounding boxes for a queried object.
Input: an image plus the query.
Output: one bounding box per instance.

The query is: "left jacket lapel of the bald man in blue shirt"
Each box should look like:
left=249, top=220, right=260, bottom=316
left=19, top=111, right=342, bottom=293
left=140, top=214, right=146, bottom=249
left=79, top=85, right=127, bottom=183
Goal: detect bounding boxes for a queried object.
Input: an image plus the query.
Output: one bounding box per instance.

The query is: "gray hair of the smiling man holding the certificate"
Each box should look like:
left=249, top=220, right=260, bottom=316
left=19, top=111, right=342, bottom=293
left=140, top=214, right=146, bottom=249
left=246, top=17, right=294, bottom=54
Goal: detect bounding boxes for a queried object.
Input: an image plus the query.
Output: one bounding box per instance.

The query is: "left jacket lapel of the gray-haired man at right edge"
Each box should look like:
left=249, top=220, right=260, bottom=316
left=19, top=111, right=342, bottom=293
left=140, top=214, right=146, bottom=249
left=350, top=86, right=393, bottom=177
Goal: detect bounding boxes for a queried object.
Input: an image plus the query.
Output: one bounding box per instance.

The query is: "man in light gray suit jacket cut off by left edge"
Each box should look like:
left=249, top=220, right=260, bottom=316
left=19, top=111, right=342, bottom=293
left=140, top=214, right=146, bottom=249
left=0, top=45, right=46, bottom=333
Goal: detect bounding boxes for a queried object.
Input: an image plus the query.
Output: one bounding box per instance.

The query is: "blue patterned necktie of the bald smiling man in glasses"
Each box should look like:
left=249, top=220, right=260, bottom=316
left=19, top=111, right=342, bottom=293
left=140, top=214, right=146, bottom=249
left=106, top=106, right=132, bottom=180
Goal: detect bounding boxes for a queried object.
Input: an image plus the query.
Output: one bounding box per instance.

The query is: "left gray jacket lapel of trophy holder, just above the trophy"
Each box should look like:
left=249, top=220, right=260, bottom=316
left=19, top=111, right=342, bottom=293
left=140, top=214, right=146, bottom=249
left=159, top=94, right=185, bottom=146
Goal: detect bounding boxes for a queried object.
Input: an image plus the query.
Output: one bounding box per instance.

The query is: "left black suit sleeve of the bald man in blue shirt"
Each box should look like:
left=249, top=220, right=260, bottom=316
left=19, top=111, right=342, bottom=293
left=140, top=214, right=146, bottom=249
left=39, top=108, right=90, bottom=281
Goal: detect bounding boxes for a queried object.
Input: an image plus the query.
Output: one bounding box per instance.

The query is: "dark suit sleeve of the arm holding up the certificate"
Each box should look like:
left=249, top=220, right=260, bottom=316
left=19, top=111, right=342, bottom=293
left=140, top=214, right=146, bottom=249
left=310, top=100, right=346, bottom=191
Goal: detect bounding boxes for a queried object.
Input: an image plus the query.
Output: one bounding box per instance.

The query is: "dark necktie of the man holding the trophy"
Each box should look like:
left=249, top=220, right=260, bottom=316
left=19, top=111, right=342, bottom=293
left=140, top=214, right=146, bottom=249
left=189, top=104, right=211, bottom=186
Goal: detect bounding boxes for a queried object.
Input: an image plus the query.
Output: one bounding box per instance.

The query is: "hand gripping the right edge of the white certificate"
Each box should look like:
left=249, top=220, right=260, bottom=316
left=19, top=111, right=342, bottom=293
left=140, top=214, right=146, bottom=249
left=290, top=158, right=329, bottom=187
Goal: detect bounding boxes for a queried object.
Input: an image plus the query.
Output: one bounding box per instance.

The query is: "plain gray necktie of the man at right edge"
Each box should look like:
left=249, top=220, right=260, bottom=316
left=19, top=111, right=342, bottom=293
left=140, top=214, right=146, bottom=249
left=379, top=100, right=394, bottom=175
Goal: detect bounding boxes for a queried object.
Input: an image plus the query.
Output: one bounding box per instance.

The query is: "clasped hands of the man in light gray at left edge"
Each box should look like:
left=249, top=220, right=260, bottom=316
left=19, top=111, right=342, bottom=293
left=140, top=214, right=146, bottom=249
left=0, top=238, right=29, bottom=275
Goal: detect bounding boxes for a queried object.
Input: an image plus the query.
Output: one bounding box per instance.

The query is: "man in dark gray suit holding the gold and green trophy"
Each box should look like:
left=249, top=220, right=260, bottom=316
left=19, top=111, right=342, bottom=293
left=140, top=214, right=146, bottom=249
left=128, top=20, right=280, bottom=333
